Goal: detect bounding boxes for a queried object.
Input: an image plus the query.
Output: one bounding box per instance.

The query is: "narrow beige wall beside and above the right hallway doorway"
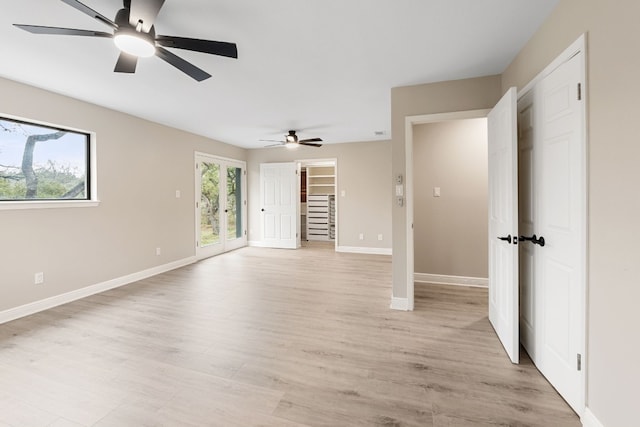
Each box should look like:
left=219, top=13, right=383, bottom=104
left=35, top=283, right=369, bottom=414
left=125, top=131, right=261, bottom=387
left=391, top=76, right=501, bottom=298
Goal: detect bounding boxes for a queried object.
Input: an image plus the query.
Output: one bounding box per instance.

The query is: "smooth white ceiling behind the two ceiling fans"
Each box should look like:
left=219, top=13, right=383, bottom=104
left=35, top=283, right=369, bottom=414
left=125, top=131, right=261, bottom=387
left=0, top=0, right=558, bottom=148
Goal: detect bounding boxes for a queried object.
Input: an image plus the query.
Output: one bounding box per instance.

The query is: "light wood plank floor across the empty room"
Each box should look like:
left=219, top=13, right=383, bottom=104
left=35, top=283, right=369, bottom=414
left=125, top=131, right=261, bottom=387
left=0, top=245, right=580, bottom=427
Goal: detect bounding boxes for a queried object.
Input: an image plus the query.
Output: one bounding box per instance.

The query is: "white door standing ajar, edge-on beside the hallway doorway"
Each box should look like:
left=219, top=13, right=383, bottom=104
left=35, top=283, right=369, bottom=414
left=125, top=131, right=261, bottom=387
left=488, top=88, right=520, bottom=363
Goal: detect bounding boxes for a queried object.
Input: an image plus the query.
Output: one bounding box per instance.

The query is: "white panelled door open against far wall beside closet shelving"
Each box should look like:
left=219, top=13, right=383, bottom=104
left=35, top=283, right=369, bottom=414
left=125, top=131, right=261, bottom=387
left=260, top=162, right=299, bottom=249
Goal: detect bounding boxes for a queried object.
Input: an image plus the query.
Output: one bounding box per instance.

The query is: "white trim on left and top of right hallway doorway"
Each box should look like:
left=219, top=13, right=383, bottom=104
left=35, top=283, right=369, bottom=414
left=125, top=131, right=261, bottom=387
left=404, top=108, right=491, bottom=311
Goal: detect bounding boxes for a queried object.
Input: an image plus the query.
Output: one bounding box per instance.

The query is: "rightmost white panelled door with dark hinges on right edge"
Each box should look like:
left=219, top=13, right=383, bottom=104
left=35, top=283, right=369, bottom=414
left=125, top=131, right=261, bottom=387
left=534, top=53, right=586, bottom=413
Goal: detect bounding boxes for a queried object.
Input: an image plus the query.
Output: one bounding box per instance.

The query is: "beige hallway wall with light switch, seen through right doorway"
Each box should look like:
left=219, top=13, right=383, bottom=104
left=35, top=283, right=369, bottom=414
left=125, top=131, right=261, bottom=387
left=413, top=119, right=488, bottom=278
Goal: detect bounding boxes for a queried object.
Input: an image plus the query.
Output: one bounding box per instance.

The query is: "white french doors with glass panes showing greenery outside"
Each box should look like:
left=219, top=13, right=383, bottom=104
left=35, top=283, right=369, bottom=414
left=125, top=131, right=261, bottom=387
left=195, top=153, right=247, bottom=258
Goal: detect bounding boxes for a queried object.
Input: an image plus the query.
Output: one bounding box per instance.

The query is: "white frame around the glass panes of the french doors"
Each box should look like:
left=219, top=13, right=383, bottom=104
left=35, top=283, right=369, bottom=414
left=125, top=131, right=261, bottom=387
left=193, top=151, right=247, bottom=259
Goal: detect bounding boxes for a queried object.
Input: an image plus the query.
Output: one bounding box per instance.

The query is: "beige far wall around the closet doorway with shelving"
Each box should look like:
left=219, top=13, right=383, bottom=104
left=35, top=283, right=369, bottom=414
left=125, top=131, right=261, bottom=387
left=247, top=141, right=392, bottom=249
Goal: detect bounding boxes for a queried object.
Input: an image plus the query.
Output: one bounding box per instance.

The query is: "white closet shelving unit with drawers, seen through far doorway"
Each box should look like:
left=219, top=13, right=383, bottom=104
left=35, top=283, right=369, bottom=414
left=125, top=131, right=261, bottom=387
left=307, top=166, right=336, bottom=240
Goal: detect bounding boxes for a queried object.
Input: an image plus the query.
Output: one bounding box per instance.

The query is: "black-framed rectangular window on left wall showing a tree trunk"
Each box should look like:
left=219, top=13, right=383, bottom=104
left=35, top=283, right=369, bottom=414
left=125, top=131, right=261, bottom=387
left=0, top=117, right=94, bottom=204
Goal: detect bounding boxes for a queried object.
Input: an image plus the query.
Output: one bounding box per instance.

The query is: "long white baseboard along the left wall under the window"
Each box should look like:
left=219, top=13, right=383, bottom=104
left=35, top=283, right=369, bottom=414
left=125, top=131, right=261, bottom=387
left=0, top=257, right=197, bottom=324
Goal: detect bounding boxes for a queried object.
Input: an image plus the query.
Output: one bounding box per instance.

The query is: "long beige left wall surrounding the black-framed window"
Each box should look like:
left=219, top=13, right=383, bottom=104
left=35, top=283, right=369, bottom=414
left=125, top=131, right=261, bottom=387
left=0, top=79, right=246, bottom=311
